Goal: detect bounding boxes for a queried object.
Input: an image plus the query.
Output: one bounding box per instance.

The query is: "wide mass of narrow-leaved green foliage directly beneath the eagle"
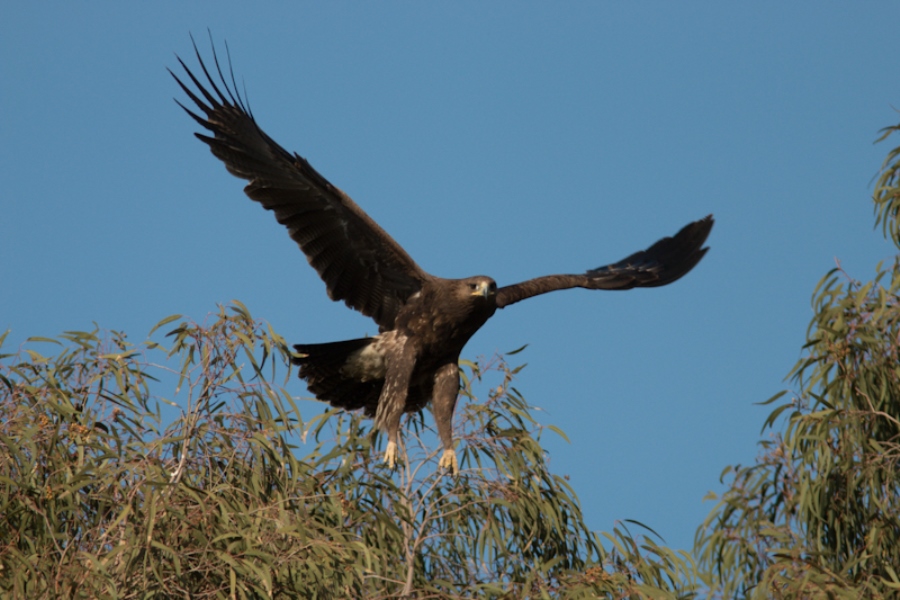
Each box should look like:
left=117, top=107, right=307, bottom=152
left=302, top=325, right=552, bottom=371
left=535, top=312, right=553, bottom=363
left=0, top=304, right=694, bottom=598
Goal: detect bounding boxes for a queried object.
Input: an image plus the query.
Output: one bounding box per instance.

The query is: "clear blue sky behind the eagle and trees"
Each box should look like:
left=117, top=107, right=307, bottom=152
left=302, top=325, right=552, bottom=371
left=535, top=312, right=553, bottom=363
left=0, top=1, right=900, bottom=548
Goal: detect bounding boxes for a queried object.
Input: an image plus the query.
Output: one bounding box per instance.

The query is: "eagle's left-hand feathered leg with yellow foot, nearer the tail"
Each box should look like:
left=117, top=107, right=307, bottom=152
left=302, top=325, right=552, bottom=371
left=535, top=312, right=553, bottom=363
left=375, top=339, right=416, bottom=469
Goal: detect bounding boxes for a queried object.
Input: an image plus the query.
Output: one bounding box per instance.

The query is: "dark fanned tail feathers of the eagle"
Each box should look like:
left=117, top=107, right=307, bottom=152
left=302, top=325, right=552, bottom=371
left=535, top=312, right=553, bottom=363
left=293, top=338, right=384, bottom=417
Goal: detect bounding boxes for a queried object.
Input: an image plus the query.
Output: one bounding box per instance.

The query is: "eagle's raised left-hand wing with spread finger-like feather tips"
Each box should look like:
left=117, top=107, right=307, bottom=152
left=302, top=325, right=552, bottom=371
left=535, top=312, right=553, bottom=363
left=169, top=38, right=430, bottom=329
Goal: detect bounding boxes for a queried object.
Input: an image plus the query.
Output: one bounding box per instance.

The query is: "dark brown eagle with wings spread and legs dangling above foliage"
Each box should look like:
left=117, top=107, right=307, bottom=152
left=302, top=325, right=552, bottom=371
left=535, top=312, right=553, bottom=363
left=169, top=44, right=713, bottom=475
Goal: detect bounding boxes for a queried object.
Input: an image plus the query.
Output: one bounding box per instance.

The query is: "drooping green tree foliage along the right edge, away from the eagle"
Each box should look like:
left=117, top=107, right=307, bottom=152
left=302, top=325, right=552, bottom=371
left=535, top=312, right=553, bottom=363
left=696, top=120, right=900, bottom=598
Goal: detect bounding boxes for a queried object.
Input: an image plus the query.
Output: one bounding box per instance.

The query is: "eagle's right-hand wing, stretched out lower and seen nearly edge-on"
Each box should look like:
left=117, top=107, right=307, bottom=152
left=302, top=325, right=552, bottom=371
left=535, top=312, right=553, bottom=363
left=497, top=215, right=713, bottom=308
